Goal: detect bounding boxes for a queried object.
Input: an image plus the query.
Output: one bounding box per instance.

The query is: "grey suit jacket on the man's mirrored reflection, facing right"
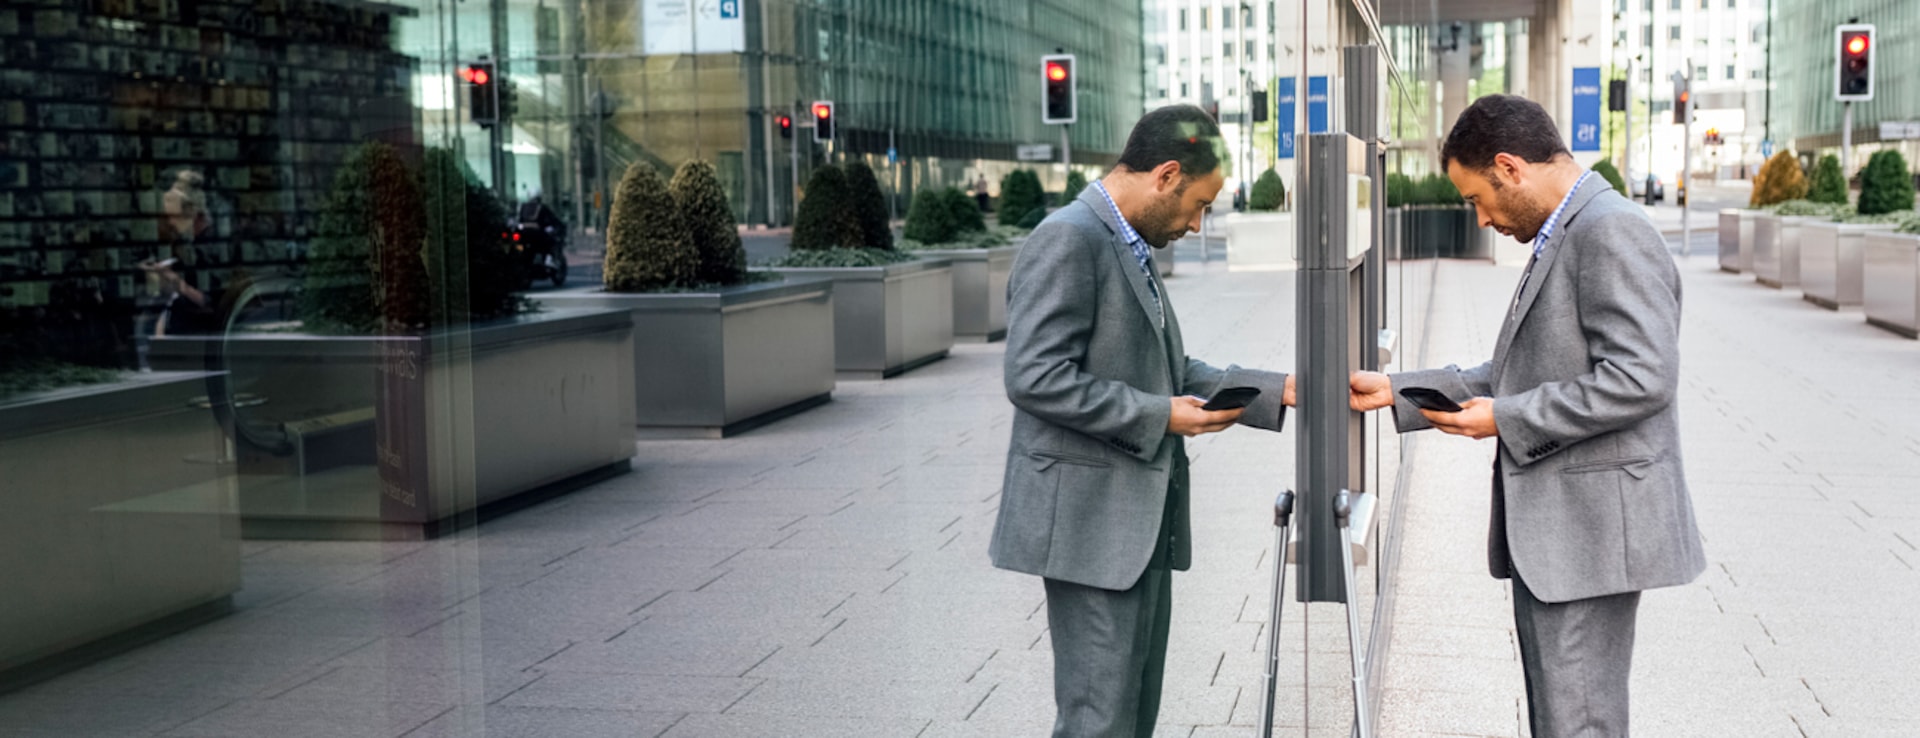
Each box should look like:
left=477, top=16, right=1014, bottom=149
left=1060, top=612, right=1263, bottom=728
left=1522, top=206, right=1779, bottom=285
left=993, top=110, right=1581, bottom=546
left=989, top=186, right=1286, bottom=590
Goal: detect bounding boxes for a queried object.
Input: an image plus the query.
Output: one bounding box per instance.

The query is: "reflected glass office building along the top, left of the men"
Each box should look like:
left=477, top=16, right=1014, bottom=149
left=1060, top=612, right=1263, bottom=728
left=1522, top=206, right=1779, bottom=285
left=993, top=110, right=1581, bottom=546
left=439, top=0, right=1142, bottom=223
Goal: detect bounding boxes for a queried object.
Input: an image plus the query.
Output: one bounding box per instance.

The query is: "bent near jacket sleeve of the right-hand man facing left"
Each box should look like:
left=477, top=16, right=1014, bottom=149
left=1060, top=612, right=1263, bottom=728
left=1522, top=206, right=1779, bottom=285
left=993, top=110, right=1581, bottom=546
left=1494, top=213, right=1680, bottom=465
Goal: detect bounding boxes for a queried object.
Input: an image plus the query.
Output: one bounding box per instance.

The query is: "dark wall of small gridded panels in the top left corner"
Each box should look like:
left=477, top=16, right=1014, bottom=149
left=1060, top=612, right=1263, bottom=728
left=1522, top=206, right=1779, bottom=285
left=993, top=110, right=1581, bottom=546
left=0, top=0, right=419, bottom=363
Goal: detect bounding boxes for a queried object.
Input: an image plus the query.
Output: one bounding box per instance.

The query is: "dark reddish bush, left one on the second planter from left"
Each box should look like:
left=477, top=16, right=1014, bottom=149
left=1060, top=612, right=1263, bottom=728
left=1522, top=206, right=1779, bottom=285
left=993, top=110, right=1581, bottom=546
left=300, top=142, right=428, bottom=332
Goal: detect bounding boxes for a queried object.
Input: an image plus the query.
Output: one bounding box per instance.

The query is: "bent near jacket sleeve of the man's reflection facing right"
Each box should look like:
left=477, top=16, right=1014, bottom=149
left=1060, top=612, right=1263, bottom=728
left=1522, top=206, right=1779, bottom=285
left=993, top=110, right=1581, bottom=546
left=1004, top=219, right=1171, bottom=461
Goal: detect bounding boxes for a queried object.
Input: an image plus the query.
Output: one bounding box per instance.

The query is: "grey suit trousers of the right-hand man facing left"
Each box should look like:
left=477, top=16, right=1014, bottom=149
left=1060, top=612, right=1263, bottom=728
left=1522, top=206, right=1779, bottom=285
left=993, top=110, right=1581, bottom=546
left=1488, top=463, right=1640, bottom=738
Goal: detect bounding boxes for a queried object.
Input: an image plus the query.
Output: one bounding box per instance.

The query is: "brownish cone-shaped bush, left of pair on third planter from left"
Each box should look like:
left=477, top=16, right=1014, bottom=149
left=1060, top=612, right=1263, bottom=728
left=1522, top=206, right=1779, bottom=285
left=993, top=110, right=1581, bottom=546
left=605, top=161, right=701, bottom=292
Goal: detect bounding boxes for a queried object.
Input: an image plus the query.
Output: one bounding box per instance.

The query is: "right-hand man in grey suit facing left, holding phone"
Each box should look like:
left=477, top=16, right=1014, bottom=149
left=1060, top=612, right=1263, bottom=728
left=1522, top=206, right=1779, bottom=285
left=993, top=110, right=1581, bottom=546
left=1352, top=94, right=1707, bottom=738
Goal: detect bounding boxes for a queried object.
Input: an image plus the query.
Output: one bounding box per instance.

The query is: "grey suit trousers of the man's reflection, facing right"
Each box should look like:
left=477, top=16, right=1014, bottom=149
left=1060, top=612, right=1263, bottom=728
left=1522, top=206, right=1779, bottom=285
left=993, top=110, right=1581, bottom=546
left=1043, top=484, right=1175, bottom=738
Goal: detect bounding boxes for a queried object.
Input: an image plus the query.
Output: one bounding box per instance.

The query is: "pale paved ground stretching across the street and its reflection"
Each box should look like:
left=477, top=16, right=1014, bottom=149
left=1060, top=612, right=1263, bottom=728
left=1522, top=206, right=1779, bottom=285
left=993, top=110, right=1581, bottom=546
left=0, top=244, right=1920, bottom=738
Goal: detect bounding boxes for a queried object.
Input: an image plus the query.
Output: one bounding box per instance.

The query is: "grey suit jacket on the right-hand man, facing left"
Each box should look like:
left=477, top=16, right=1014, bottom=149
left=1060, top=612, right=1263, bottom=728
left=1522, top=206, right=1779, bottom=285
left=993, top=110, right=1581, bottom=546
left=1392, top=177, right=1707, bottom=602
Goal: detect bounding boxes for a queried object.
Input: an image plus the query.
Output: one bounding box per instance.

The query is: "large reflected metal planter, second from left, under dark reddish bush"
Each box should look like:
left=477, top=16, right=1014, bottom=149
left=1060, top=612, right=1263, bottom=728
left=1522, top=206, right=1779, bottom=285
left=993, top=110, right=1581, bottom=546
left=150, top=309, right=636, bottom=540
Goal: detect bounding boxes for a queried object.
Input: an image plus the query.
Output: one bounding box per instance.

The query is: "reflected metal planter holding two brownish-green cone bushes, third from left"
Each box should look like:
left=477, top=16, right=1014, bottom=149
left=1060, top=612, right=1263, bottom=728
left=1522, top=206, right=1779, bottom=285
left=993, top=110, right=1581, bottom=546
left=540, top=277, right=833, bottom=438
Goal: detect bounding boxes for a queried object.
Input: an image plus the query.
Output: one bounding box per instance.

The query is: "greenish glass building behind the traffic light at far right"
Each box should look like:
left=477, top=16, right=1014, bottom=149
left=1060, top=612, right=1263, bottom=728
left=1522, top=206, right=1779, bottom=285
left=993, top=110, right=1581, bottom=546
left=1774, top=0, right=1920, bottom=171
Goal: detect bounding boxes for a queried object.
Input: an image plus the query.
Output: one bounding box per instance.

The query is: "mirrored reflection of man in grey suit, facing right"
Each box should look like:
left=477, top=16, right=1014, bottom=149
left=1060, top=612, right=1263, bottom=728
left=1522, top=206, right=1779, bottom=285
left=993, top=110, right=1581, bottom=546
left=989, top=106, right=1292, bottom=736
